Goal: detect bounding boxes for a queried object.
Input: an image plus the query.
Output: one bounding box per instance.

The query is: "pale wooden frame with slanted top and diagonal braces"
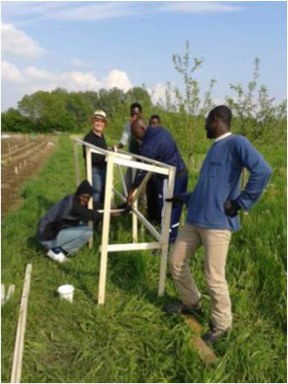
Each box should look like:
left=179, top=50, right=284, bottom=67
left=74, top=139, right=176, bottom=304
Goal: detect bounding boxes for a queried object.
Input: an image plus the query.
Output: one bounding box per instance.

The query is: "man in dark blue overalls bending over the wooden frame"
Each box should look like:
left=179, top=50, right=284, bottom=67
left=127, top=119, right=188, bottom=244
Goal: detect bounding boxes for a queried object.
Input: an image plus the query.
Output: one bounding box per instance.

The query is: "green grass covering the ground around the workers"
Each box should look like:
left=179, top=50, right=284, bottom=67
left=2, top=136, right=287, bottom=383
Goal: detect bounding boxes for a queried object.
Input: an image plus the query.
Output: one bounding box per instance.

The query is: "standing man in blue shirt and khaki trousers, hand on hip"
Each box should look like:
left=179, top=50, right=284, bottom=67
left=163, top=106, right=271, bottom=343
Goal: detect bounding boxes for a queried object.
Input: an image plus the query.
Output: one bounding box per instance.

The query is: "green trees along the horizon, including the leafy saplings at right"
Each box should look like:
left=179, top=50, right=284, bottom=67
left=2, top=41, right=287, bottom=147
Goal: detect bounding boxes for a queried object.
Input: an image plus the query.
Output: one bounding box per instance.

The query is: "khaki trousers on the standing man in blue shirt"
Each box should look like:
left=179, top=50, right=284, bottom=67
left=169, top=224, right=232, bottom=330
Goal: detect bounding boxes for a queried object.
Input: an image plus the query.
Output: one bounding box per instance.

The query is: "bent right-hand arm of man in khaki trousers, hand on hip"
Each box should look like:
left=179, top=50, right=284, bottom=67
left=228, top=137, right=272, bottom=214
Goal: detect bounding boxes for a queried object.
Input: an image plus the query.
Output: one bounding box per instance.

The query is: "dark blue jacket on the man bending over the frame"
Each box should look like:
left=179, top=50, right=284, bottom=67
left=134, top=127, right=187, bottom=188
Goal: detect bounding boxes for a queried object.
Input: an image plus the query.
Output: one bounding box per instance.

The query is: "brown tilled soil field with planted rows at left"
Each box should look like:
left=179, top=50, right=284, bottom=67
left=1, top=134, right=58, bottom=218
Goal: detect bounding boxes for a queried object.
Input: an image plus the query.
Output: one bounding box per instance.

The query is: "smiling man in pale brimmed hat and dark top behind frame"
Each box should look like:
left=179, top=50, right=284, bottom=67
left=83, top=110, right=107, bottom=203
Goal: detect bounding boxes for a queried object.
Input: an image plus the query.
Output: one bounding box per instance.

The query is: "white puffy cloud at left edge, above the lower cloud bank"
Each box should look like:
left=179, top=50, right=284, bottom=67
left=1, top=23, right=45, bottom=58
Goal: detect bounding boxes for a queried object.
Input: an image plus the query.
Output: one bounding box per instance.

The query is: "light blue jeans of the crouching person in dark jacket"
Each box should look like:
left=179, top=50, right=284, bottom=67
left=41, top=225, right=93, bottom=255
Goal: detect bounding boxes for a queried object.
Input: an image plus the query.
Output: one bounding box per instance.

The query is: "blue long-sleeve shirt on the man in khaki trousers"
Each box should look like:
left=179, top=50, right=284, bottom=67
left=182, top=135, right=271, bottom=231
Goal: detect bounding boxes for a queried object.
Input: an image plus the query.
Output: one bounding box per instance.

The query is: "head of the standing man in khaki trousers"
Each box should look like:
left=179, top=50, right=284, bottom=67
left=205, top=105, right=232, bottom=139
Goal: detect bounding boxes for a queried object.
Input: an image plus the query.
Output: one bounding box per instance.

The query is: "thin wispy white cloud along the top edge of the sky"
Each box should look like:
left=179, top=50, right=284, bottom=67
left=2, top=1, right=241, bottom=22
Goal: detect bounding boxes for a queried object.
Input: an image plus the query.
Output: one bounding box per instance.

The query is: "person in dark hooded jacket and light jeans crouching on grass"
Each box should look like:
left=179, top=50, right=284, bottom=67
left=36, top=180, right=103, bottom=263
